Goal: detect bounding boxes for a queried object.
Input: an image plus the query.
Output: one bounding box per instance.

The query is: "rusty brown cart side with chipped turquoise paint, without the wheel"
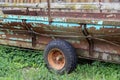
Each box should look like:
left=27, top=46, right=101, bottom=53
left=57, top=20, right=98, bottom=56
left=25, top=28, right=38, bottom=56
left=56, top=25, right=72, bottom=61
left=0, top=4, right=120, bottom=63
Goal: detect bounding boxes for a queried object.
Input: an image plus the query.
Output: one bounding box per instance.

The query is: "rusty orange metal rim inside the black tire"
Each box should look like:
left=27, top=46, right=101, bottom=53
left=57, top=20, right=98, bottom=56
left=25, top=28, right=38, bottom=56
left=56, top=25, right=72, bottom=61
left=48, top=49, right=65, bottom=70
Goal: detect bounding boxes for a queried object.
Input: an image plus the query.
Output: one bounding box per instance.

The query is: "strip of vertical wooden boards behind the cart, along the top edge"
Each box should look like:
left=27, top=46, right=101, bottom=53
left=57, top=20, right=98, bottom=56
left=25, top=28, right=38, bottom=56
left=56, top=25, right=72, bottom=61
left=0, top=0, right=120, bottom=3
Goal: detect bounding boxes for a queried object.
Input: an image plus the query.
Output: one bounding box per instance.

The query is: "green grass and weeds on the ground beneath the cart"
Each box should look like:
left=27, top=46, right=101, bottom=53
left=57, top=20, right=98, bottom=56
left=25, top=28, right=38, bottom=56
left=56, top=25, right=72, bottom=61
left=0, top=46, right=120, bottom=80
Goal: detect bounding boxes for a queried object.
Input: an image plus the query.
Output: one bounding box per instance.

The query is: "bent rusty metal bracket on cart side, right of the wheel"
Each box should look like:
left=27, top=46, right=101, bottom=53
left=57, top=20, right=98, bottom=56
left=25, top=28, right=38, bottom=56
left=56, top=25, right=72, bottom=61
left=81, top=24, right=94, bottom=56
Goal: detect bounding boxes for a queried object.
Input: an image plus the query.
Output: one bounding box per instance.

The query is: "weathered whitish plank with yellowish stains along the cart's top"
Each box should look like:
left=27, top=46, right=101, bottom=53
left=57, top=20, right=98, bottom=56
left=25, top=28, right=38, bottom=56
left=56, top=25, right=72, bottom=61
left=0, top=2, right=120, bottom=11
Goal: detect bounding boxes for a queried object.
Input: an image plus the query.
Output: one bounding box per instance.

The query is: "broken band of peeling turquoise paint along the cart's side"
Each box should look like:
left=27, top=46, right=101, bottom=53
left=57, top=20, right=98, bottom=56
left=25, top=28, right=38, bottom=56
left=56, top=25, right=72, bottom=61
left=1, top=15, right=119, bottom=30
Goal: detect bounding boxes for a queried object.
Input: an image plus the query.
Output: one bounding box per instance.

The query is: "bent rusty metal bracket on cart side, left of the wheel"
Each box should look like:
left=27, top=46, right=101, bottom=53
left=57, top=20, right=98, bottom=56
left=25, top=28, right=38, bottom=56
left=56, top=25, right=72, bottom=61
left=22, top=20, right=36, bottom=47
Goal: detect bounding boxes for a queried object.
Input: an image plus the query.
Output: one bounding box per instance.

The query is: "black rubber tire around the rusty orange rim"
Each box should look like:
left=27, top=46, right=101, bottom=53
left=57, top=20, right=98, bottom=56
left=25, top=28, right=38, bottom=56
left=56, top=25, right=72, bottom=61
left=44, top=40, right=77, bottom=74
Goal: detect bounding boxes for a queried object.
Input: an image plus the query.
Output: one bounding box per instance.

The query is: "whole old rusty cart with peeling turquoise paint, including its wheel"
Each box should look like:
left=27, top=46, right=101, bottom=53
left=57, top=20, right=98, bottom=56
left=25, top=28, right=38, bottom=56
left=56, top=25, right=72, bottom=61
left=0, top=0, right=120, bottom=73
